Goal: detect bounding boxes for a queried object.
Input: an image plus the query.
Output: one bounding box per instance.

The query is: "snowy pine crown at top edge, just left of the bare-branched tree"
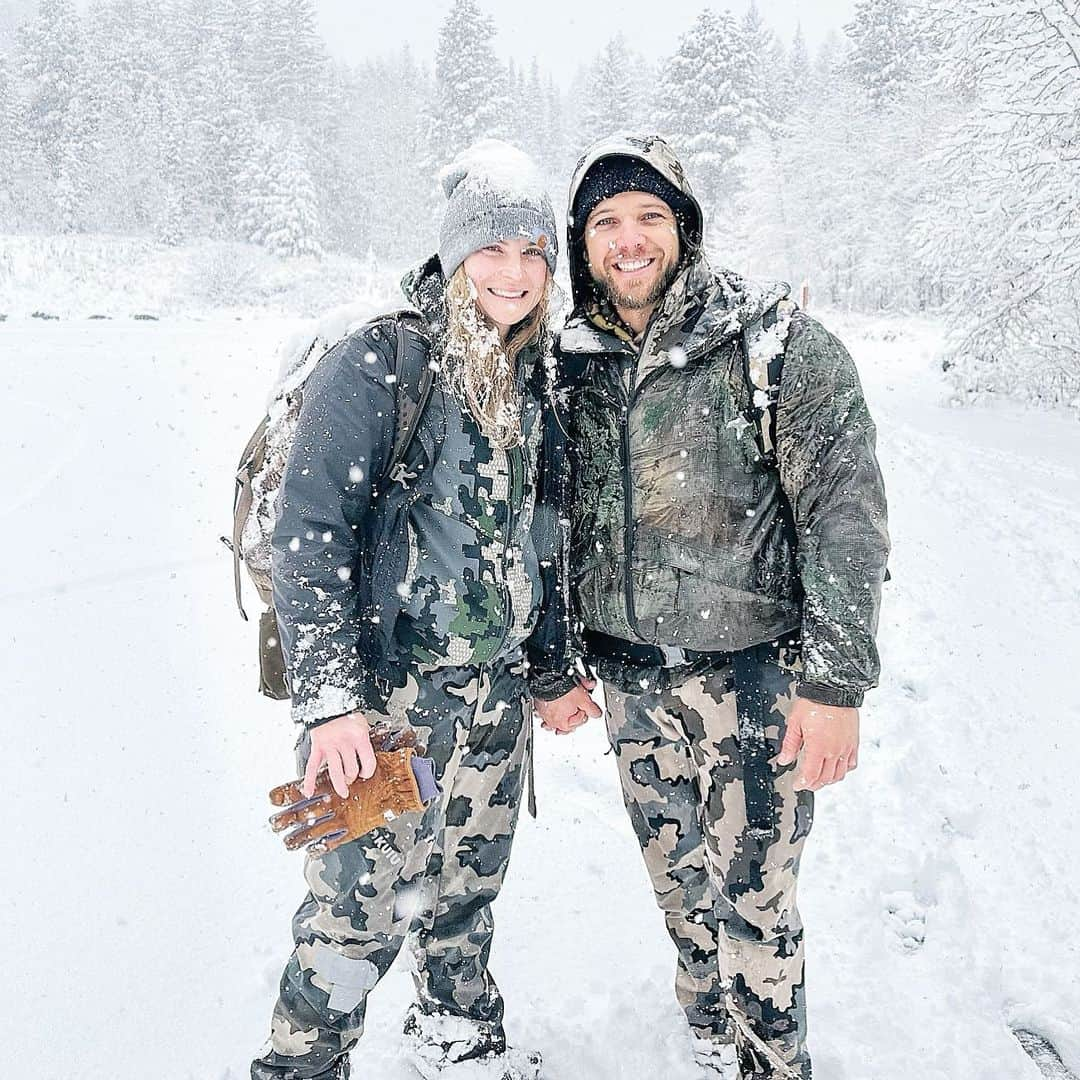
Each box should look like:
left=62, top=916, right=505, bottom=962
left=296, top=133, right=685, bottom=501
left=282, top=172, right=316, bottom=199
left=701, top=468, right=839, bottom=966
left=843, top=0, right=921, bottom=108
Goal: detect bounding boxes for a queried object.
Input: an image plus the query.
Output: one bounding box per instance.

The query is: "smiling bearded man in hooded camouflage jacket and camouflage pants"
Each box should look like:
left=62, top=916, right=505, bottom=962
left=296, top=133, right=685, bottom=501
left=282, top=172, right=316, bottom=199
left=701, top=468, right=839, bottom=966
left=537, top=137, right=889, bottom=1080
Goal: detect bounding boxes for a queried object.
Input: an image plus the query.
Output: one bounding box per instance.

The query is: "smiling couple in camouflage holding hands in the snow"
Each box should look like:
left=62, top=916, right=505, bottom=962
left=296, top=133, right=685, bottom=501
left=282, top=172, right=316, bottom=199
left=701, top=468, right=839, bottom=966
left=252, top=136, right=888, bottom=1080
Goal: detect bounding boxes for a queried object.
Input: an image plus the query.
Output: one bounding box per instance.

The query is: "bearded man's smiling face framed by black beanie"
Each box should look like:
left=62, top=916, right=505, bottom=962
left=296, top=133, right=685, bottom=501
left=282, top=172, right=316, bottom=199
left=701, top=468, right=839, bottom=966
left=585, top=191, right=679, bottom=310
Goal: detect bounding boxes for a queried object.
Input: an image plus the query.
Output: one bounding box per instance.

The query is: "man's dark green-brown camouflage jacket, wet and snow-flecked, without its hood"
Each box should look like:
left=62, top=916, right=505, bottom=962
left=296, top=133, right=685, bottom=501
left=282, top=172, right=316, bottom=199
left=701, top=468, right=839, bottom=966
left=556, top=256, right=889, bottom=705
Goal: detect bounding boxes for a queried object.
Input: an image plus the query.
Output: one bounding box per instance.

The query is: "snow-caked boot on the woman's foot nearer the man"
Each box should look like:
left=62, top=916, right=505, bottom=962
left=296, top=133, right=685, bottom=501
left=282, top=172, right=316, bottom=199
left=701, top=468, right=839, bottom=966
left=404, top=1004, right=542, bottom=1080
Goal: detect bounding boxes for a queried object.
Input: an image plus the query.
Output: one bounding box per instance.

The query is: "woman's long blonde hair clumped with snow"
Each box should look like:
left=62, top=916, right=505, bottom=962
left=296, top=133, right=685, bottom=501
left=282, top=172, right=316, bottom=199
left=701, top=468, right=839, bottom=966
left=442, top=266, right=551, bottom=450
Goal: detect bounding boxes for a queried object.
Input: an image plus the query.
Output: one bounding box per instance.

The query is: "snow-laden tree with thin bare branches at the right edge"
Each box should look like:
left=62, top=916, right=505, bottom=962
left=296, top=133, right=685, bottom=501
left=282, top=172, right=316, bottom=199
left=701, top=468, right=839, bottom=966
left=919, top=0, right=1080, bottom=410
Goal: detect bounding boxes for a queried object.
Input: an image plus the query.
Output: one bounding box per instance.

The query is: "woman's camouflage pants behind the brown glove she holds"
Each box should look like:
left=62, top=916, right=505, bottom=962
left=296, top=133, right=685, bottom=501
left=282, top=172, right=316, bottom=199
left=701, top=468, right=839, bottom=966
left=252, top=661, right=531, bottom=1080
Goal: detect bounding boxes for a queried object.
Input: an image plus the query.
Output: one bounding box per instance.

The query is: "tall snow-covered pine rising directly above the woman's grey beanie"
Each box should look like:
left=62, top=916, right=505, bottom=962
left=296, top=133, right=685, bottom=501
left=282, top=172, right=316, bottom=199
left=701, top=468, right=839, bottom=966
left=424, top=0, right=512, bottom=177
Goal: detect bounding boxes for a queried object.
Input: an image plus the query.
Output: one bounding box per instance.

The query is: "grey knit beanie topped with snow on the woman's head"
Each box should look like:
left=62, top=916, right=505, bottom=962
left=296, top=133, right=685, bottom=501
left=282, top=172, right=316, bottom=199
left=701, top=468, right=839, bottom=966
left=438, top=138, right=558, bottom=281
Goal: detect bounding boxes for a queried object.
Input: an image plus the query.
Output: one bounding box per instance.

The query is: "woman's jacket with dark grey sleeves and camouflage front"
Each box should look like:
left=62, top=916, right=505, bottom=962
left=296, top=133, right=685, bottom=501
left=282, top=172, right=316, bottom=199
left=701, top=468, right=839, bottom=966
left=272, top=259, right=561, bottom=725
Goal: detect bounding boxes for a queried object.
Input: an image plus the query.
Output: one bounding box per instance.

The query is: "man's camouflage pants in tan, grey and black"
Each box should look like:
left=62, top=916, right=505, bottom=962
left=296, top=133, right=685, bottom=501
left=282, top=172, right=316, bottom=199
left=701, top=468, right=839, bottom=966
left=606, top=645, right=813, bottom=1080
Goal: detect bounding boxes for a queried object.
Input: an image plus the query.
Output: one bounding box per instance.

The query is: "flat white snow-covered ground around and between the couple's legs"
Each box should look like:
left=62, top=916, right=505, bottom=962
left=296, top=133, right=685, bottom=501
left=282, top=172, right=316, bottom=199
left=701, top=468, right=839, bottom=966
left=0, top=298, right=1080, bottom=1080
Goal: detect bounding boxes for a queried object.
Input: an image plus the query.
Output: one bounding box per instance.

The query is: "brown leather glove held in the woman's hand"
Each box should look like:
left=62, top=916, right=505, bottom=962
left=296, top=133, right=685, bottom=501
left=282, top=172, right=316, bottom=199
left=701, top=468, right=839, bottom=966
left=270, top=740, right=424, bottom=855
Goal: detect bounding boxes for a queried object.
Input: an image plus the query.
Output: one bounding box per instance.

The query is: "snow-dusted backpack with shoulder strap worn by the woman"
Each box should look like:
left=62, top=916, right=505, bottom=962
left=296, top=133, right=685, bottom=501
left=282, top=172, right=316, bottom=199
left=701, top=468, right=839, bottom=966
left=221, top=310, right=435, bottom=700
